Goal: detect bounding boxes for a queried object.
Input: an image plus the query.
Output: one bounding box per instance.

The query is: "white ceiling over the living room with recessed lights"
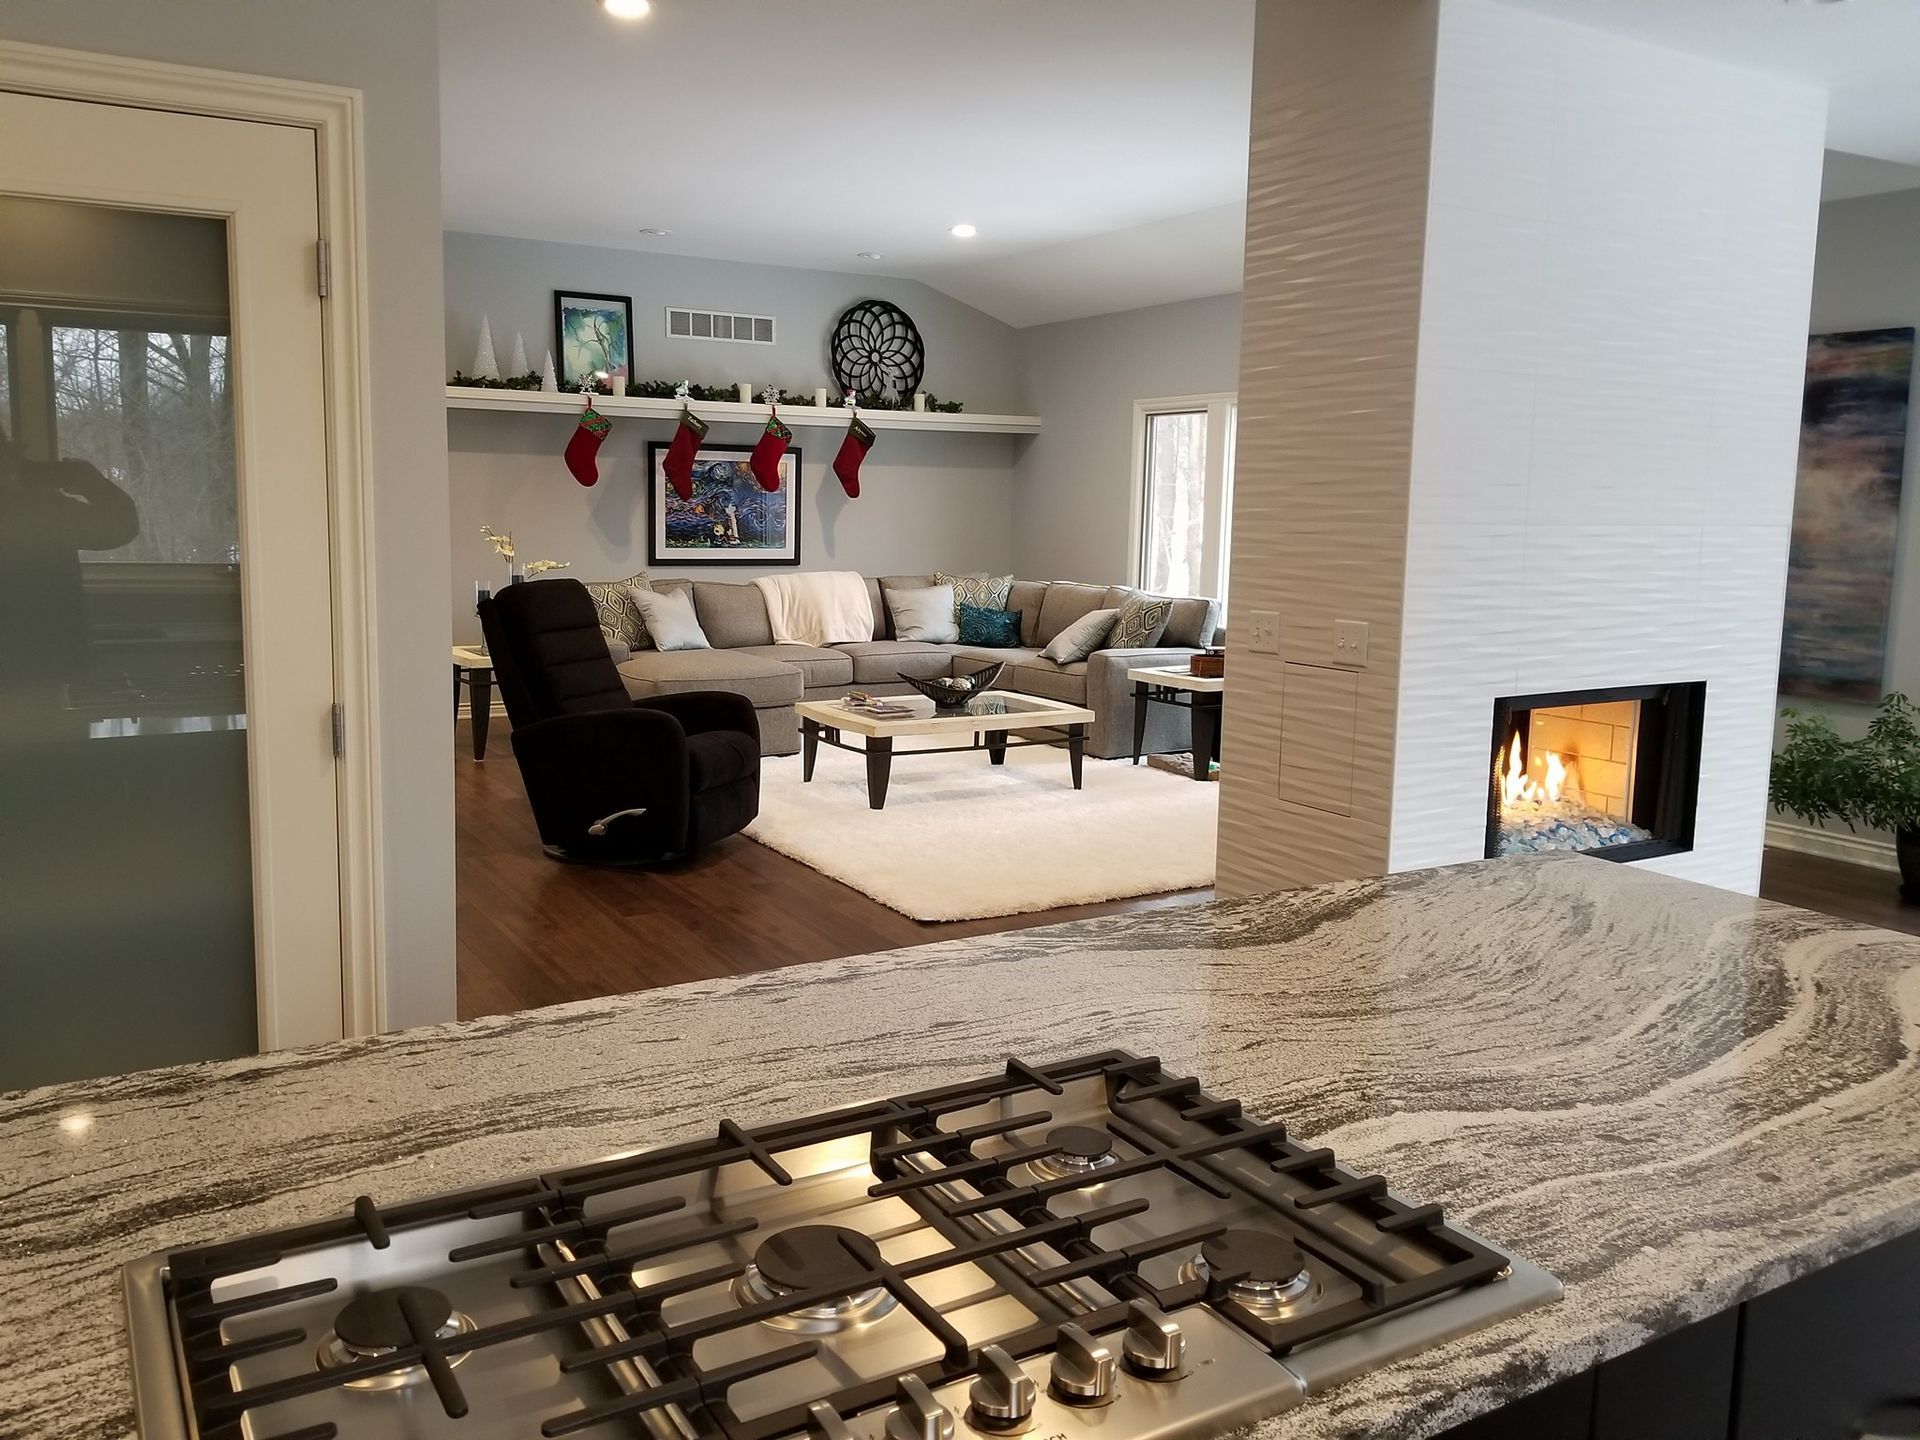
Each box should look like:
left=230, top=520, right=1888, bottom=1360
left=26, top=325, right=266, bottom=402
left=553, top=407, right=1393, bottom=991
left=440, top=0, right=1254, bottom=324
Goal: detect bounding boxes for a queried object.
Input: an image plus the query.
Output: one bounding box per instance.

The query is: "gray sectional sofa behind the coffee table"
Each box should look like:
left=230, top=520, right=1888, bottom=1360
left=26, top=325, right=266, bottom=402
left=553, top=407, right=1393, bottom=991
left=609, top=576, right=1219, bottom=760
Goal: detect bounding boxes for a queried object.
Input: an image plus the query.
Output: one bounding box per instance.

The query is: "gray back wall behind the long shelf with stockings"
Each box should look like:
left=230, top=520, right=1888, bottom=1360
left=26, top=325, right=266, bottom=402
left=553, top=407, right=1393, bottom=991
left=445, top=234, right=1027, bottom=641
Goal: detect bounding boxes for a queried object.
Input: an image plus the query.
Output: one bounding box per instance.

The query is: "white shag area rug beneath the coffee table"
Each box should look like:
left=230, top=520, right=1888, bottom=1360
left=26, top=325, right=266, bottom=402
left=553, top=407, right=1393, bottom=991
left=745, top=739, right=1219, bottom=920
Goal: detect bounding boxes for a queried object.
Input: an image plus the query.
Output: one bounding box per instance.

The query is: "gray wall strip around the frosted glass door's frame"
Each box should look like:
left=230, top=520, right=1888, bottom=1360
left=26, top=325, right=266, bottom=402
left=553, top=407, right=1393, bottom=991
left=0, top=0, right=455, bottom=1025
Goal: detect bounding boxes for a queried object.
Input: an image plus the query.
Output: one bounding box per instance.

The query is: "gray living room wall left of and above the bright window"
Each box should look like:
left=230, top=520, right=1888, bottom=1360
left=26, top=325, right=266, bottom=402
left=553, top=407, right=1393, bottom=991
left=1014, top=296, right=1240, bottom=582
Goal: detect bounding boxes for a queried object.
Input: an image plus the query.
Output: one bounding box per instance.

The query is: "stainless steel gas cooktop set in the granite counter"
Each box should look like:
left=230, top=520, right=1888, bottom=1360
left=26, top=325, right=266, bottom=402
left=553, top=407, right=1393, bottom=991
left=127, top=1050, right=1561, bottom=1440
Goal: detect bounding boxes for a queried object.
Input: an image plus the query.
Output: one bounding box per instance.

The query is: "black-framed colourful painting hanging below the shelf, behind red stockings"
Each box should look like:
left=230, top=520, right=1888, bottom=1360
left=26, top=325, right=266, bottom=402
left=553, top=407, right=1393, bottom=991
left=647, top=442, right=801, bottom=566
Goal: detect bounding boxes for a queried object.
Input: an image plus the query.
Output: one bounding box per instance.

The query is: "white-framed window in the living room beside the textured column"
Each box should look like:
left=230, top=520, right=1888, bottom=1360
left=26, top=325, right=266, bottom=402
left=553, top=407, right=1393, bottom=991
left=1133, top=396, right=1236, bottom=601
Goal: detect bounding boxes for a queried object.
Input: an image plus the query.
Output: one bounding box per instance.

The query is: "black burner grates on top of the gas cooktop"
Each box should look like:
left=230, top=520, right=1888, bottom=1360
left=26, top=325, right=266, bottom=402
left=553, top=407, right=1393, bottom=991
left=169, top=1050, right=1505, bottom=1440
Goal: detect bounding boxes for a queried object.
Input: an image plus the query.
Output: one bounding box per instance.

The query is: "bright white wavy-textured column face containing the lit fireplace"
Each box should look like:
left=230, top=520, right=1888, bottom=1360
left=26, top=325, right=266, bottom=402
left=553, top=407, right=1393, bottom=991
left=1388, top=0, right=1826, bottom=891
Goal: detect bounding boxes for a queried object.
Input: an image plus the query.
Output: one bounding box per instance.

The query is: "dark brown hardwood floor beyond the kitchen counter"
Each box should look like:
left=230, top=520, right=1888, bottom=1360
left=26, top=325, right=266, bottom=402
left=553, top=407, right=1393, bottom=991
left=453, top=720, right=1920, bottom=1020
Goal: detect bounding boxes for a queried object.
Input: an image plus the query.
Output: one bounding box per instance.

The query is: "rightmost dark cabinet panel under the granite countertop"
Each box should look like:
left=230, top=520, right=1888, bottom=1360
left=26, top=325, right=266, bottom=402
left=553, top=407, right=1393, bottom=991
left=1734, top=1235, right=1920, bottom=1440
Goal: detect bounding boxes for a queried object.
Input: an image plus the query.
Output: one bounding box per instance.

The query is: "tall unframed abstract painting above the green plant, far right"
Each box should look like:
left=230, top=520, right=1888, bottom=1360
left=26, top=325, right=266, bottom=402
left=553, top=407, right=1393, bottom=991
left=1780, top=326, right=1914, bottom=705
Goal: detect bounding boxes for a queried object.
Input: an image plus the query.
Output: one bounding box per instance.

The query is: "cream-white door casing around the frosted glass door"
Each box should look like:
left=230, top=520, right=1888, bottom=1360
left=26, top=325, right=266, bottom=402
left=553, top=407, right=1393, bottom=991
left=0, top=40, right=386, bottom=1050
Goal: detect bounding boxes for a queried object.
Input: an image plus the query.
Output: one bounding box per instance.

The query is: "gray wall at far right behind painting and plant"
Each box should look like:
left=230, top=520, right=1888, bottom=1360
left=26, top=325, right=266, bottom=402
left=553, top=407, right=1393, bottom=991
left=1780, top=190, right=1920, bottom=852
